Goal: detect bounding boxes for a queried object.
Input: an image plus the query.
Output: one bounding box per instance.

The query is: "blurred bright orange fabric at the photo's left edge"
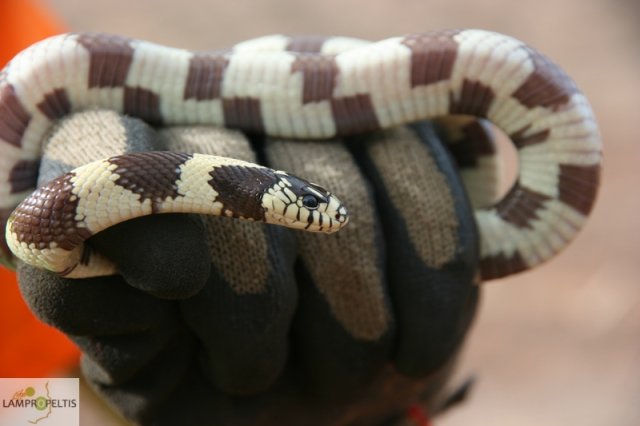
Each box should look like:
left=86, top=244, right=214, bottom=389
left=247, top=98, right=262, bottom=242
left=0, top=0, right=79, bottom=377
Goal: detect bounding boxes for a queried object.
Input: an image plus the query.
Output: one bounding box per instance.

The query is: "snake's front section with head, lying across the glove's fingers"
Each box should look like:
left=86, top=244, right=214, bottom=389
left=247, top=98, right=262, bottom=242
left=6, top=151, right=348, bottom=278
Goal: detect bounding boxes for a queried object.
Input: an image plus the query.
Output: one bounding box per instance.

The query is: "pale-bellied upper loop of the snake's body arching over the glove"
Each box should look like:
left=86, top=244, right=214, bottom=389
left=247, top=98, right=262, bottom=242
left=0, top=30, right=601, bottom=279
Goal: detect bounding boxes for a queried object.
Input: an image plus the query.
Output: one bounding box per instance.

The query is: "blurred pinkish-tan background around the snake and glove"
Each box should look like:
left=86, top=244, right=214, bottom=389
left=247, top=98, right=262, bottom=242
left=0, top=0, right=640, bottom=426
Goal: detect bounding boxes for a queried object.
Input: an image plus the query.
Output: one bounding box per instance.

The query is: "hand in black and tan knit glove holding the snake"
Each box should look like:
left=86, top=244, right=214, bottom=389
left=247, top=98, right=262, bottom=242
left=19, top=111, right=478, bottom=425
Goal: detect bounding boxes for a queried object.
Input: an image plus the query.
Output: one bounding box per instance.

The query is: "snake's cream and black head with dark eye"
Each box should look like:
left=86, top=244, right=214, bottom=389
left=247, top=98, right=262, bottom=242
left=262, top=171, right=349, bottom=233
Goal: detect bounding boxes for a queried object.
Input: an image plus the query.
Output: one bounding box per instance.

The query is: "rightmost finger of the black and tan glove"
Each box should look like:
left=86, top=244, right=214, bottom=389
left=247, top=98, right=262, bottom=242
left=357, top=124, right=478, bottom=377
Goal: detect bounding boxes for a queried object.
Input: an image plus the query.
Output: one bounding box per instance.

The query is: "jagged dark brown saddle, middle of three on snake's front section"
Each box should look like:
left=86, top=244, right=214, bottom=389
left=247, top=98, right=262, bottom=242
left=108, top=151, right=191, bottom=213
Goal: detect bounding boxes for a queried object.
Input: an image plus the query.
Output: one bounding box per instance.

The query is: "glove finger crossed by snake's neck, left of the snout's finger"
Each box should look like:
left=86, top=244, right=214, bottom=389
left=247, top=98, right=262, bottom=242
left=162, top=128, right=297, bottom=395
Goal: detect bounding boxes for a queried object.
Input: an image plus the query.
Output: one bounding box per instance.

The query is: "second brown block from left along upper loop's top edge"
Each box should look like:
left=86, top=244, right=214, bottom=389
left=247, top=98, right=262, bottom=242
left=184, top=52, right=229, bottom=101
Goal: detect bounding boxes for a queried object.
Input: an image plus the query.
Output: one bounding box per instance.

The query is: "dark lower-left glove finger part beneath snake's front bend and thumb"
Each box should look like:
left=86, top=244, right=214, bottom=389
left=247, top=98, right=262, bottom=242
left=18, top=264, right=182, bottom=383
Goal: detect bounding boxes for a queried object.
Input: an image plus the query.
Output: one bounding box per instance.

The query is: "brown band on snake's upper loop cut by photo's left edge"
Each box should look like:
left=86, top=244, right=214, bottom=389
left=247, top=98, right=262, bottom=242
left=0, top=83, right=31, bottom=148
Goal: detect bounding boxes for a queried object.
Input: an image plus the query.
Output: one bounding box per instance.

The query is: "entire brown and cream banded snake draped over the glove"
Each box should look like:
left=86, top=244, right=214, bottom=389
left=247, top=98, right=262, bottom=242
left=0, top=29, right=602, bottom=279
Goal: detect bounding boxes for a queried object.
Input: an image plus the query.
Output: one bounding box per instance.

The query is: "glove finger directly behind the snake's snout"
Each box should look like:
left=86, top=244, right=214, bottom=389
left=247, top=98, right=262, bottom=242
left=265, top=140, right=394, bottom=395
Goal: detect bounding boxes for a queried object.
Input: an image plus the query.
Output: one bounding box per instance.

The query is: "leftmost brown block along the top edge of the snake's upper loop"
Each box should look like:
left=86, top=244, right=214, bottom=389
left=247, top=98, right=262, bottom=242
left=77, top=33, right=134, bottom=88
